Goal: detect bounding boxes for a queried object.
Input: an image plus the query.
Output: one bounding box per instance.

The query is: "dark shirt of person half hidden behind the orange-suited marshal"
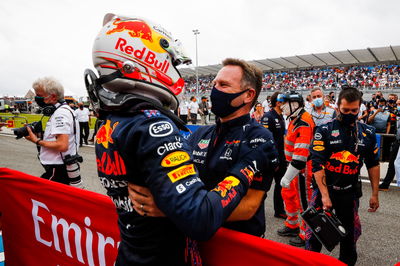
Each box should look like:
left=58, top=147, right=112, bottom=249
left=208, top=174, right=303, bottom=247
left=261, top=109, right=286, bottom=163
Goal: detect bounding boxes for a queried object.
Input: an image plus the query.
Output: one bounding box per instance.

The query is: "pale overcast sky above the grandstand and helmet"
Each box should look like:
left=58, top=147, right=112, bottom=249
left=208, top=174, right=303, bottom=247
left=0, top=0, right=400, bottom=96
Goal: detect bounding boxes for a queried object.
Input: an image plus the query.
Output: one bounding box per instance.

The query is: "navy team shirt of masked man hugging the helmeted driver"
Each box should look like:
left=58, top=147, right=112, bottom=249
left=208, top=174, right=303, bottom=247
left=189, top=115, right=278, bottom=236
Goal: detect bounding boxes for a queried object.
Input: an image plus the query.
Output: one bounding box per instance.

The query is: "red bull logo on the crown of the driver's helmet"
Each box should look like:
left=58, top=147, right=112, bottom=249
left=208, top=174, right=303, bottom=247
left=107, top=18, right=153, bottom=42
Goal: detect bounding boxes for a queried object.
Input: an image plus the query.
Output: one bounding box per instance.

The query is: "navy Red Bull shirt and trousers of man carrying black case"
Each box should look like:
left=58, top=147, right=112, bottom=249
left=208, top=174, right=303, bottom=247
left=306, top=119, right=379, bottom=265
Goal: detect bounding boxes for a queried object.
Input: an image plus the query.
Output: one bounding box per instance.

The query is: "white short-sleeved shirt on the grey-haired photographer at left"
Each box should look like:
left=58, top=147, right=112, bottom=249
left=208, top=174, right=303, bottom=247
left=39, top=103, right=79, bottom=165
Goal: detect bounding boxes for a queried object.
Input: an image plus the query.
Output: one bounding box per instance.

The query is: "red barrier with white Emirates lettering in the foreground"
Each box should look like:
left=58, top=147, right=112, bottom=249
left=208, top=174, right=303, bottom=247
left=0, top=168, right=344, bottom=266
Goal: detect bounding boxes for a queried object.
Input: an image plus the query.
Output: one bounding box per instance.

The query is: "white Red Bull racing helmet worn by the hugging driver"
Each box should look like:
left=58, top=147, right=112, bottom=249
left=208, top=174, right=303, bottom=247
left=92, top=14, right=191, bottom=109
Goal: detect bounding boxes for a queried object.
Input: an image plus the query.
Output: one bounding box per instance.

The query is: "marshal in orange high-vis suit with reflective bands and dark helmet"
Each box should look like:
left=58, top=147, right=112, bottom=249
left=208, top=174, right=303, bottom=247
left=278, top=91, right=315, bottom=247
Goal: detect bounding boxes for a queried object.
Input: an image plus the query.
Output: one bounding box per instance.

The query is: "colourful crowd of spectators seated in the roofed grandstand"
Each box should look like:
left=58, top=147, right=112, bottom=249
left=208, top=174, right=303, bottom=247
left=186, top=65, right=400, bottom=93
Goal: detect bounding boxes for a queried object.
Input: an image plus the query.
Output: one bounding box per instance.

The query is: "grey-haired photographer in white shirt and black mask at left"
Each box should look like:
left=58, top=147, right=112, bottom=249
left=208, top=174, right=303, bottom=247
left=25, top=77, right=82, bottom=187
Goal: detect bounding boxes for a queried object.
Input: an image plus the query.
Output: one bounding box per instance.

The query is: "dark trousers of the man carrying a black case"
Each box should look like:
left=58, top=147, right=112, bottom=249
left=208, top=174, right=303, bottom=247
left=306, top=189, right=361, bottom=265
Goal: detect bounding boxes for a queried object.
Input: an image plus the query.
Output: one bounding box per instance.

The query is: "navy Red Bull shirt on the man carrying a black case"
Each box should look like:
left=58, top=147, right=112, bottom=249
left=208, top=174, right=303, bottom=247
left=311, top=119, right=379, bottom=189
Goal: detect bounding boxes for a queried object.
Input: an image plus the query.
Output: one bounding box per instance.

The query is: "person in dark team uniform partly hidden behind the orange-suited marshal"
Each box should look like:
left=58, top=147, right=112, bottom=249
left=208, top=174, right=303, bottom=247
left=261, top=91, right=287, bottom=219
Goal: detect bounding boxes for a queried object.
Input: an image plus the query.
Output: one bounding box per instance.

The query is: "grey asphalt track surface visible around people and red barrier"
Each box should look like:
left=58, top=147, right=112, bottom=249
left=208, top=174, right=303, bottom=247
left=0, top=134, right=400, bottom=266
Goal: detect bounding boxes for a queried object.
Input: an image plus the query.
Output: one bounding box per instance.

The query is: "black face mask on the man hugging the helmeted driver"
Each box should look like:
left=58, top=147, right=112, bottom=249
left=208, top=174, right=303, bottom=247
left=210, top=86, right=248, bottom=118
